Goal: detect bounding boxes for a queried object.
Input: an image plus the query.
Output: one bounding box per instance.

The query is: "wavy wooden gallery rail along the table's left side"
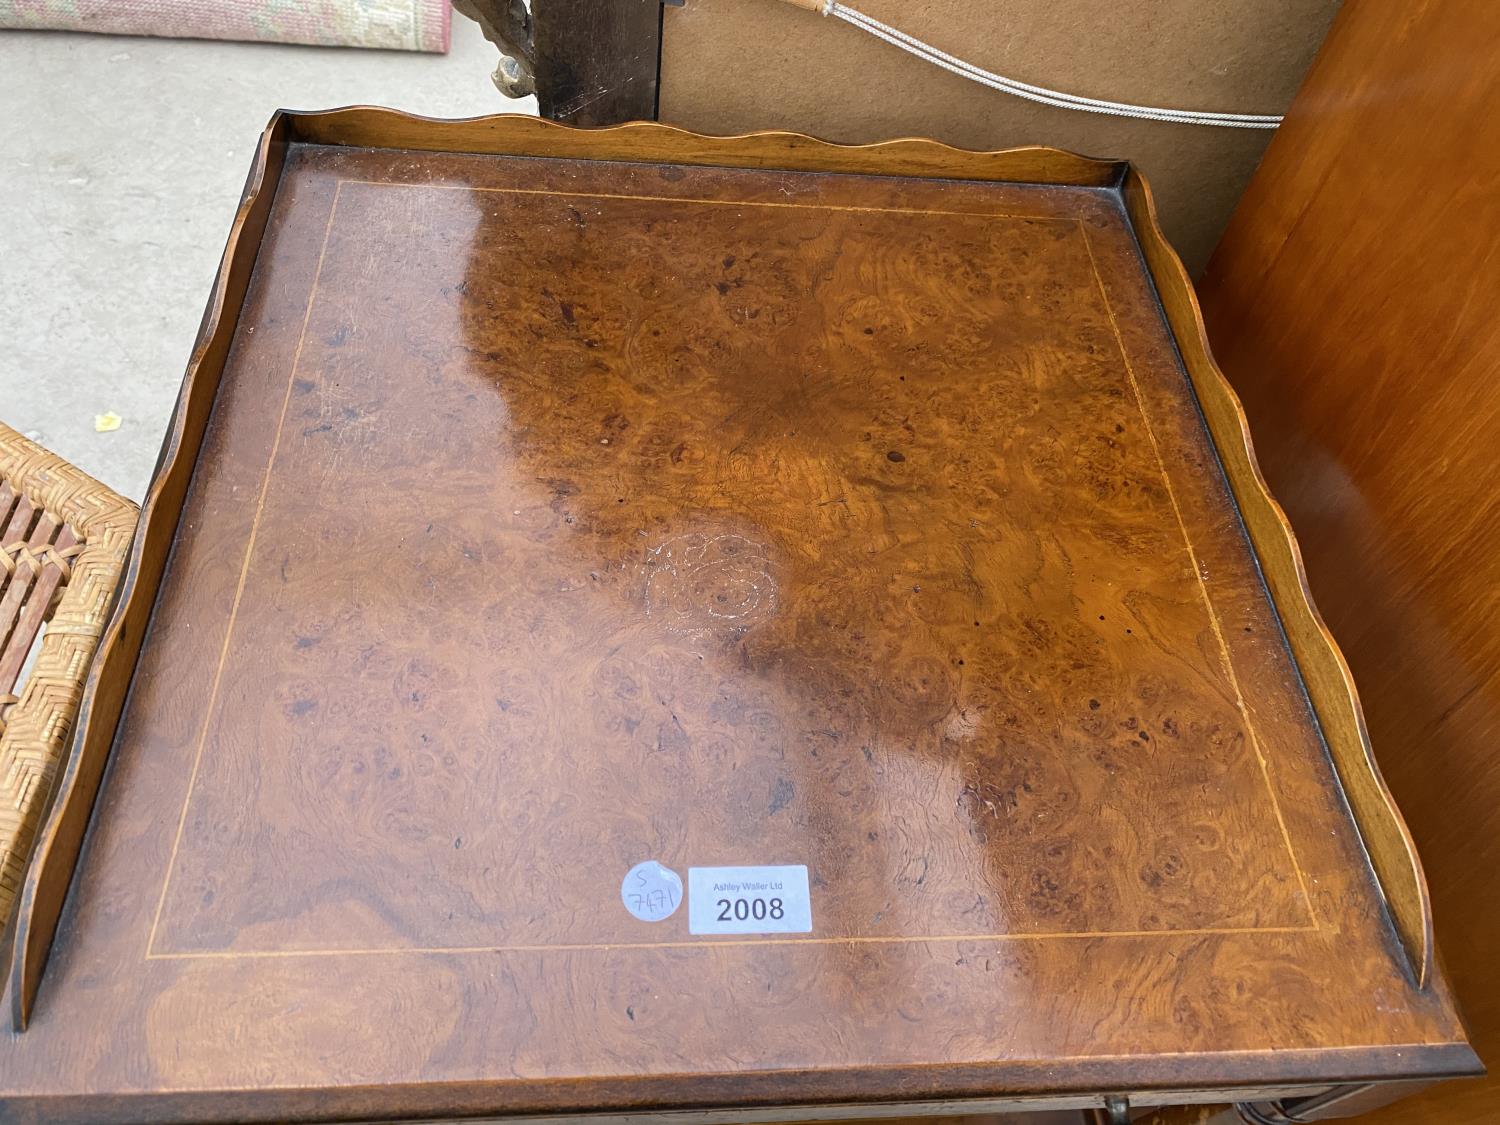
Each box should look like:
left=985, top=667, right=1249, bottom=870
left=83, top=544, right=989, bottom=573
left=8, top=113, right=288, bottom=1032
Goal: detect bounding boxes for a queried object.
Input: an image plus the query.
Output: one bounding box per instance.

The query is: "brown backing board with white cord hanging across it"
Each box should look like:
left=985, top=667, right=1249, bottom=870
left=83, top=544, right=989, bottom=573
left=660, top=0, right=1338, bottom=275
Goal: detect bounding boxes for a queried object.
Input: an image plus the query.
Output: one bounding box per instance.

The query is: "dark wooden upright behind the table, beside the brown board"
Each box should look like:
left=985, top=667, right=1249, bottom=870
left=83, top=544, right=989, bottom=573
left=531, top=0, right=662, bottom=126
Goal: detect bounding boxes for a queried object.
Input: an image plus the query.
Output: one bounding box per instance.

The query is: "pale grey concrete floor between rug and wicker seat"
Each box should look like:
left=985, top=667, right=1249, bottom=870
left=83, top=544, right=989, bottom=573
left=0, top=15, right=536, bottom=501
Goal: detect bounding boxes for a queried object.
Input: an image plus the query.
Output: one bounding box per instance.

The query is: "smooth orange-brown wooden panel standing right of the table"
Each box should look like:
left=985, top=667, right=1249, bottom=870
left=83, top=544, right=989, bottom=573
left=1202, top=0, right=1500, bottom=1125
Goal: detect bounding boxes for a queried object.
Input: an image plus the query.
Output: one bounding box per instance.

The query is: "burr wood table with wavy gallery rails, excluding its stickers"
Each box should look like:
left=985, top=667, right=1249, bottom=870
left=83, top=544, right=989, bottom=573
left=0, top=110, right=1476, bottom=1121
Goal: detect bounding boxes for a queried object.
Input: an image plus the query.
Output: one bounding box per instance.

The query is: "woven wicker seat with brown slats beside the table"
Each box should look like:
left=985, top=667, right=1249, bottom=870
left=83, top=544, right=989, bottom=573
left=0, top=423, right=138, bottom=936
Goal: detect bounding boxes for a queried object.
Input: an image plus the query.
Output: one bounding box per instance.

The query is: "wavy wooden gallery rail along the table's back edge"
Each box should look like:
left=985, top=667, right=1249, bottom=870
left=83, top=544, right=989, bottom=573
left=287, top=105, right=1125, bottom=188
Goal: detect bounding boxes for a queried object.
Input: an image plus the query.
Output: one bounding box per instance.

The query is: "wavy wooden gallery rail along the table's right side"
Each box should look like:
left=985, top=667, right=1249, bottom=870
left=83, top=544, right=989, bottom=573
left=1121, top=168, right=1434, bottom=989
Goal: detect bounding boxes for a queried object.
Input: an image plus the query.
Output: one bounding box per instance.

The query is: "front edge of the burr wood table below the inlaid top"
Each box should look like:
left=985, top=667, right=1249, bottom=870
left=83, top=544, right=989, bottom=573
left=0, top=1043, right=1484, bottom=1125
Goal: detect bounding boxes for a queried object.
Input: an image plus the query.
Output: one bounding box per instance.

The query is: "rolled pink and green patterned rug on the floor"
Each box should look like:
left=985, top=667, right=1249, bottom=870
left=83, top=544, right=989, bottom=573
left=0, top=0, right=449, bottom=53
